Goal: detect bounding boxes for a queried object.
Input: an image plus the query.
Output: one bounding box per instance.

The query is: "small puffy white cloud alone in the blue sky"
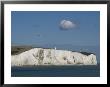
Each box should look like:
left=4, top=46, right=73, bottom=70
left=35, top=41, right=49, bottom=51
left=60, top=20, right=76, bottom=30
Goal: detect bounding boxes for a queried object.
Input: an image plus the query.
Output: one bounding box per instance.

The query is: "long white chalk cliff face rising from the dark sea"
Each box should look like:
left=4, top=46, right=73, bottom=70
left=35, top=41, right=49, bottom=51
left=11, top=48, right=97, bottom=66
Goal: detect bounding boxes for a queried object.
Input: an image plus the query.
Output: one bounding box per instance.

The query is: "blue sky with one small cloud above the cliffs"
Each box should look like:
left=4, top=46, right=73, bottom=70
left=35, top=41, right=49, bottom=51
left=11, top=11, right=100, bottom=46
